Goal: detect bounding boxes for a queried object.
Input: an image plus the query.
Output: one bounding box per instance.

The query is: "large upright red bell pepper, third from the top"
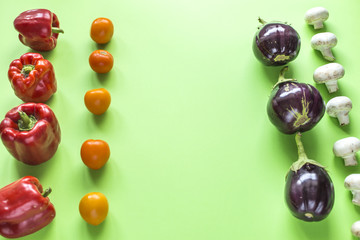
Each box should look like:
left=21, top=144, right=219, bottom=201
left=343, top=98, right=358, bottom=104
left=0, top=103, right=61, bottom=165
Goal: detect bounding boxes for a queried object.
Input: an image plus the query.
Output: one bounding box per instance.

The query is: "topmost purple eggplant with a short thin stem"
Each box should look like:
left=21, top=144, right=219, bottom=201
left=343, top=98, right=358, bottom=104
left=253, top=18, right=301, bottom=66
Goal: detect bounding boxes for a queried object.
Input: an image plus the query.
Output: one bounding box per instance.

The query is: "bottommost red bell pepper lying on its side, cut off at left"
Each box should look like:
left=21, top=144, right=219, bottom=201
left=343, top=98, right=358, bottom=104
left=0, top=176, right=55, bottom=238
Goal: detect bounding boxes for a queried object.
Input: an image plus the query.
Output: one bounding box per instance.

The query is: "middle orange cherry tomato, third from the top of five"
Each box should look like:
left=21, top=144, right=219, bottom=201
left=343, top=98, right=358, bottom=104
left=84, top=88, right=111, bottom=115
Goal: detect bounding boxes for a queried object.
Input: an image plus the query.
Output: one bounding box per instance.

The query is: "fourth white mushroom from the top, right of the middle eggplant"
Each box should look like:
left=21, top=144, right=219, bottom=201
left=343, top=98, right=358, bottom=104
left=326, top=96, right=352, bottom=126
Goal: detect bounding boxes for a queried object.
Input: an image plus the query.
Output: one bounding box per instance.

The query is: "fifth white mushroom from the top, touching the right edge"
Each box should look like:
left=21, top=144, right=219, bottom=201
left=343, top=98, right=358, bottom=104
left=333, top=137, right=360, bottom=166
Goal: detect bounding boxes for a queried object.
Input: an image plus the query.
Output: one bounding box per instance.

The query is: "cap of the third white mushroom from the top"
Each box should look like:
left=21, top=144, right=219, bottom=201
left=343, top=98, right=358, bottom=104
left=313, top=63, right=345, bottom=83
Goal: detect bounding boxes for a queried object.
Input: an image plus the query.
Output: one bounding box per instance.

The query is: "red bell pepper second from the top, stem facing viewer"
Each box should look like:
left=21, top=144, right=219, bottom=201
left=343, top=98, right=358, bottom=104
left=8, top=53, right=57, bottom=102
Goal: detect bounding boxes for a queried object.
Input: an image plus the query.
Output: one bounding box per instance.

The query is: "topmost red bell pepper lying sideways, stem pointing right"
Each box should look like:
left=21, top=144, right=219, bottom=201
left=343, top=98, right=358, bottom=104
left=14, top=9, right=64, bottom=51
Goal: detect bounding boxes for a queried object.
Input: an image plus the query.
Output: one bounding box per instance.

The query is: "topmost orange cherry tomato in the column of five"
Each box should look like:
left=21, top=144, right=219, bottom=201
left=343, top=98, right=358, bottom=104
left=90, top=18, right=114, bottom=44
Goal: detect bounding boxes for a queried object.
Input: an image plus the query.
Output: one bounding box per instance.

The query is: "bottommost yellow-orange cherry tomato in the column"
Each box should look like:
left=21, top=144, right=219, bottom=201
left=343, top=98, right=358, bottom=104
left=79, top=192, right=109, bottom=226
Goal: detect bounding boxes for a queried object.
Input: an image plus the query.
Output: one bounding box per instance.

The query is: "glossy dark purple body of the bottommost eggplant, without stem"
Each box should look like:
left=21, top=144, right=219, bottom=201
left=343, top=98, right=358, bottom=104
left=285, top=163, right=335, bottom=222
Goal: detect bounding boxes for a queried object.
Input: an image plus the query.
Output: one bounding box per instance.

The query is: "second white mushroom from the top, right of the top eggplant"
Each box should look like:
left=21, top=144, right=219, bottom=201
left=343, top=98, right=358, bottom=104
left=311, top=32, right=337, bottom=61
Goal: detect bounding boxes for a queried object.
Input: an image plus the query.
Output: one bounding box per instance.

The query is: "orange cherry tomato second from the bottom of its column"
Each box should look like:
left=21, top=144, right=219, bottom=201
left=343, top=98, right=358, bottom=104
left=80, top=139, right=110, bottom=170
